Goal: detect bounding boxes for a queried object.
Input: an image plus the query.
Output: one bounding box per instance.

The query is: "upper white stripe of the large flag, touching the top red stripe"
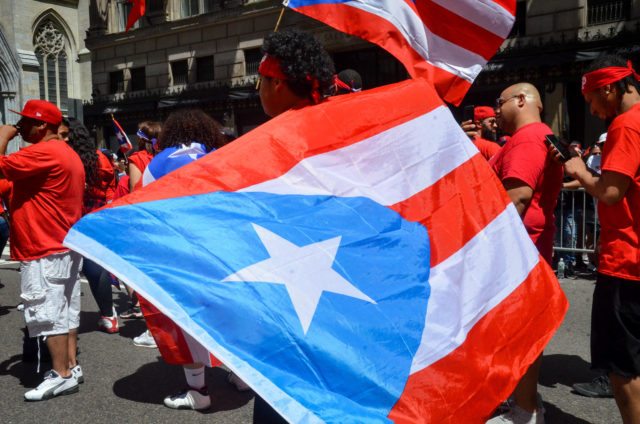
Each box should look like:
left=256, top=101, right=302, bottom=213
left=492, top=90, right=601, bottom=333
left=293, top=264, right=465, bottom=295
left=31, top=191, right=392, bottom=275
left=240, top=106, right=478, bottom=206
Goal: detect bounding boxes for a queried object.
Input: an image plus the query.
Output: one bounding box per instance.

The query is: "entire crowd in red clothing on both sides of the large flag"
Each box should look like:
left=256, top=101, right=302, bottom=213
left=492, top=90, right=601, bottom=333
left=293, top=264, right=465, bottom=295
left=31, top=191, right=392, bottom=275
left=0, top=26, right=640, bottom=424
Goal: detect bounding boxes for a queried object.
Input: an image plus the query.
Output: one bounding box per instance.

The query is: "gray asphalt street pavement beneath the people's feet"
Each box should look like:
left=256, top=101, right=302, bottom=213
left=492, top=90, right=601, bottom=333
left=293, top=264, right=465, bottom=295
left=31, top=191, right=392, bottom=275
left=0, top=256, right=622, bottom=424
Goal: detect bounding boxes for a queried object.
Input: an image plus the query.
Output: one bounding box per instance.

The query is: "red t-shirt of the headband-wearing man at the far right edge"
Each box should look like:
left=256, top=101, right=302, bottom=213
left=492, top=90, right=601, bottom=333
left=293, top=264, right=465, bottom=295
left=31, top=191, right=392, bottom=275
left=598, top=103, right=640, bottom=280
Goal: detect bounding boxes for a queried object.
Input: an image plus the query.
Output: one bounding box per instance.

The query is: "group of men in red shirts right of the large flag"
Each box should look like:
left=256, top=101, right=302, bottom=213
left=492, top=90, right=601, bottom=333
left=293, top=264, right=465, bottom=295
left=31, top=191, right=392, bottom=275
left=461, top=56, right=640, bottom=424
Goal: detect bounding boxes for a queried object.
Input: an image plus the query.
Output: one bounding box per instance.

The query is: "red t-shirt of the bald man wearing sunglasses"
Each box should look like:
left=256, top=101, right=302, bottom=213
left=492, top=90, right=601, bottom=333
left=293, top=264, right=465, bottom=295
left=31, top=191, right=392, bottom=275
left=489, top=122, right=563, bottom=263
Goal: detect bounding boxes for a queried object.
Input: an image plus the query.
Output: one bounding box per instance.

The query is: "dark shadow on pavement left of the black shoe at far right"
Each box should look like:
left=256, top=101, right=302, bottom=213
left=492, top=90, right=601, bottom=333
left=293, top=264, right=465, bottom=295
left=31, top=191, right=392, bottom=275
left=538, top=354, right=599, bottom=387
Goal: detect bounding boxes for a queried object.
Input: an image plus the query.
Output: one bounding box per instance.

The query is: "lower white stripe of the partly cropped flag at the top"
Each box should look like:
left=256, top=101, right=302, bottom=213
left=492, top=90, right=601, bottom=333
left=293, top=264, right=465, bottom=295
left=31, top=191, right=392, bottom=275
left=345, top=0, right=487, bottom=82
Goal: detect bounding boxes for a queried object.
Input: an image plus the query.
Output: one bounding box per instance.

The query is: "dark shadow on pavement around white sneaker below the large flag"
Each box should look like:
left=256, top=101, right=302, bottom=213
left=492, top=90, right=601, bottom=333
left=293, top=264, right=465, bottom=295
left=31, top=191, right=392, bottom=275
left=113, top=357, right=253, bottom=414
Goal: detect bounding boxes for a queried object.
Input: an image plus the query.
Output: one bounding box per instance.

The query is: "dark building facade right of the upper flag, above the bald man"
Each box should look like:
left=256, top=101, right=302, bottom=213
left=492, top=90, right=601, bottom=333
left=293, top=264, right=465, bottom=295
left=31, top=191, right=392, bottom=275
left=458, top=0, right=640, bottom=145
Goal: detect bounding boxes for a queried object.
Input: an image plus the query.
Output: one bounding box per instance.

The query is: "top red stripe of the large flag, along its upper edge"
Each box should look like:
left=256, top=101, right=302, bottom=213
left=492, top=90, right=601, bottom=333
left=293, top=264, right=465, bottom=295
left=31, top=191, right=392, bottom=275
left=106, top=80, right=443, bottom=207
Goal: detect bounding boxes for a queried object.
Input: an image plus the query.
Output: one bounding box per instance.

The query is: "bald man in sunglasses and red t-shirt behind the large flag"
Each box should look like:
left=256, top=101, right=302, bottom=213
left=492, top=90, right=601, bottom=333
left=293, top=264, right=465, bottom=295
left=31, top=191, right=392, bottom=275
left=488, top=83, right=563, bottom=424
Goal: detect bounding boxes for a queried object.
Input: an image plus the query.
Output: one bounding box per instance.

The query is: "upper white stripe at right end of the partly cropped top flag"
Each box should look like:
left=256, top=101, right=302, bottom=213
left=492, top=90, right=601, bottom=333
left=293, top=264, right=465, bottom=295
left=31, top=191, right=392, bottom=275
left=432, top=0, right=514, bottom=38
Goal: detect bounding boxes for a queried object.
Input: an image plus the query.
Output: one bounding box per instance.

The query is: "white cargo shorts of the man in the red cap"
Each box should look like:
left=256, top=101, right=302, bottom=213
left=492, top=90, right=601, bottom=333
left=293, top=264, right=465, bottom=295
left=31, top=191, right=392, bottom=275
left=20, top=250, right=82, bottom=337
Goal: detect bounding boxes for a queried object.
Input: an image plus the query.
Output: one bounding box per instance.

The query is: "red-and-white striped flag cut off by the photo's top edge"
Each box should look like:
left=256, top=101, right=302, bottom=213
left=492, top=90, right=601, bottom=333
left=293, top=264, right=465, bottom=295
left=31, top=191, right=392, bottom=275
left=284, top=0, right=516, bottom=105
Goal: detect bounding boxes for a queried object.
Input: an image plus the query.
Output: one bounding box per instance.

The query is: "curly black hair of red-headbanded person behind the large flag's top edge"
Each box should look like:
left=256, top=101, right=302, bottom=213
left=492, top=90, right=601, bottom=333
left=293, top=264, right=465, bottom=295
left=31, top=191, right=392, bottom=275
left=262, top=28, right=335, bottom=101
